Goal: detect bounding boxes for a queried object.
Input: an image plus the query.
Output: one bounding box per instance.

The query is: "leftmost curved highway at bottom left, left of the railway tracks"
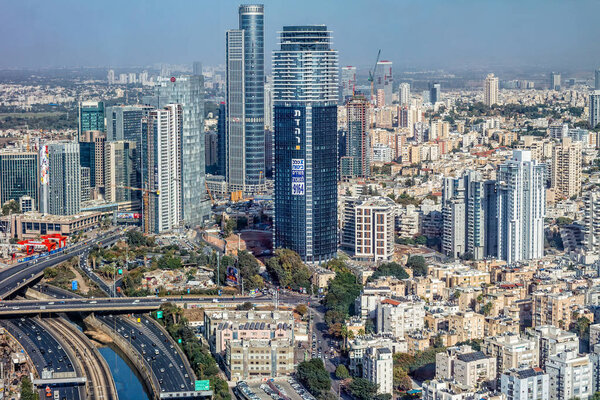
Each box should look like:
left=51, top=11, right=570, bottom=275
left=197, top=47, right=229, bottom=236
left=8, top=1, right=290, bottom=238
left=0, top=318, right=85, bottom=400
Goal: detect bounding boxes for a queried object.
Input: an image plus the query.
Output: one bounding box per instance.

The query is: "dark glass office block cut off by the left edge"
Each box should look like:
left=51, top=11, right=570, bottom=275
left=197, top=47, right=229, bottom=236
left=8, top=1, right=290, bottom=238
left=0, top=152, right=39, bottom=211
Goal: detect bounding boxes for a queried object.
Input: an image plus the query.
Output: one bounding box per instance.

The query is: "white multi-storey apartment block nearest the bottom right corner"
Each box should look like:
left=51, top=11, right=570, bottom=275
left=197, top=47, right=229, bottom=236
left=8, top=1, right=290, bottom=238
left=546, top=350, right=593, bottom=400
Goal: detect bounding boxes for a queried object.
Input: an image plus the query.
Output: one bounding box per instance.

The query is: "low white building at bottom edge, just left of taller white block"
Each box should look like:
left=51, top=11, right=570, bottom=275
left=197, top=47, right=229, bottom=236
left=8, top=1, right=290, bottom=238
left=500, top=367, right=550, bottom=400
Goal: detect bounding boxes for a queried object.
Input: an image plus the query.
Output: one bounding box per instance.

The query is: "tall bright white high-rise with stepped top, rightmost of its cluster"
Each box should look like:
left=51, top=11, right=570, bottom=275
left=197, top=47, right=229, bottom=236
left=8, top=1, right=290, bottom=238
left=496, top=150, right=546, bottom=264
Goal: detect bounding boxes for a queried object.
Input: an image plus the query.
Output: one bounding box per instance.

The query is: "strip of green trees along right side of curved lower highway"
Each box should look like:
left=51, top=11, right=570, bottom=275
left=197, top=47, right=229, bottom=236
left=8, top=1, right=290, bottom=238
left=158, top=303, right=231, bottom=400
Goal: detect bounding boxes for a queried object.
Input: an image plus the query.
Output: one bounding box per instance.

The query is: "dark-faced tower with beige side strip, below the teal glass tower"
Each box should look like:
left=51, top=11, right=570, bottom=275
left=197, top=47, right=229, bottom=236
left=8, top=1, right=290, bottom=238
left=79, top=131, right=106, bottom=199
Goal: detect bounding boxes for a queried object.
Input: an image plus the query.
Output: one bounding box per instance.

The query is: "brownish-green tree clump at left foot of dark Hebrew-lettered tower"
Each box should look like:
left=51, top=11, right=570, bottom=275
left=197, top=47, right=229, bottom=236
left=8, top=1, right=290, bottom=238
left=267, top=249, right=311, bottom=291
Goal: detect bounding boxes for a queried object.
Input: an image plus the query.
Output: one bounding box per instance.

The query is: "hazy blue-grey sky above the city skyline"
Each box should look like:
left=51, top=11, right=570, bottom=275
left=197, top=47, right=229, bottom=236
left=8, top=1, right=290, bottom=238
left=0, top=0, right=600, bottom=69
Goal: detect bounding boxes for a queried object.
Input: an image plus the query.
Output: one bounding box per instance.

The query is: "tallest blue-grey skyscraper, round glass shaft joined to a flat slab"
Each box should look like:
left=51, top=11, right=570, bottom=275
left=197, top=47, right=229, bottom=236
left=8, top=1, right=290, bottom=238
left=225, top=5, right=265, bottom=194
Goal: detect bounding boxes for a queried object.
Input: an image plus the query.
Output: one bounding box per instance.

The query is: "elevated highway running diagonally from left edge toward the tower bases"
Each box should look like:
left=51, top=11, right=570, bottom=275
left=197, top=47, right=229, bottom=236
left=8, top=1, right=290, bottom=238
left=0, top=231, right=121, bottom=299
